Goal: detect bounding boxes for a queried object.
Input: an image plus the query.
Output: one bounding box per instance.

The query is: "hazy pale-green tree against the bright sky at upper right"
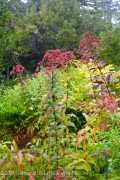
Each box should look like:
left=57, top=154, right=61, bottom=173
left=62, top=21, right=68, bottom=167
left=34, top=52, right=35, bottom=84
left=78, top=0, right=112, bottom=36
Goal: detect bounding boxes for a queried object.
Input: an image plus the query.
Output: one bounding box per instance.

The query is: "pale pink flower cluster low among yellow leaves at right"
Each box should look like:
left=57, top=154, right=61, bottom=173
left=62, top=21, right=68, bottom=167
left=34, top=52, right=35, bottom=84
left=96, top=94, right=118, bottom=114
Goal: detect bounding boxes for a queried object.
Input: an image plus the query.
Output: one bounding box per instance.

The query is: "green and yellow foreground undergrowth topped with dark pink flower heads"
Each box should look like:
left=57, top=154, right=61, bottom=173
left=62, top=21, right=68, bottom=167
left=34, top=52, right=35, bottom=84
left=0, top=34, right=120, bottom=180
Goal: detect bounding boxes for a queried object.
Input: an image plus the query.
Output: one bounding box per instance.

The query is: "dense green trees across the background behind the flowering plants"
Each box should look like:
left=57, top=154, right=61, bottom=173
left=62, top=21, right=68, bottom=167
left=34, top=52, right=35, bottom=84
left=0, top=0, right=120, bottom=75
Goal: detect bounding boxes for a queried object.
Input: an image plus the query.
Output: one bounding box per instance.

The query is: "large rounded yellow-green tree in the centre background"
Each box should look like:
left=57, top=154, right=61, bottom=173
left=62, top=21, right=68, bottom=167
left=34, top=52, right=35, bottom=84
left=10, top=0, right=80, bottom=54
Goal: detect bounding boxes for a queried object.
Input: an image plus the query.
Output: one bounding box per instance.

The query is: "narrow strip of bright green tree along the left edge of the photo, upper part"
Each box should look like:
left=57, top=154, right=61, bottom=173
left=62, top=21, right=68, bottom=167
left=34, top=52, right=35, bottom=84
left=0, top=0, right=13, bottom=76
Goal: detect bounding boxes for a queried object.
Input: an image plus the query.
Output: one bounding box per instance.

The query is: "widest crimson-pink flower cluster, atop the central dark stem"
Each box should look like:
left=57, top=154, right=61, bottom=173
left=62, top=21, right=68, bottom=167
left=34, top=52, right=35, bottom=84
left=36, top=49, right=76, bottom=73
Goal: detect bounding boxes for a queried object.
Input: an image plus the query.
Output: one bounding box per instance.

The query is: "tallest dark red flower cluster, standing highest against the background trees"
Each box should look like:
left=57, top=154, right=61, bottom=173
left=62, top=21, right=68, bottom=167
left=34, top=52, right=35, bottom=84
left=78, top=33, right=102, bottom=64
